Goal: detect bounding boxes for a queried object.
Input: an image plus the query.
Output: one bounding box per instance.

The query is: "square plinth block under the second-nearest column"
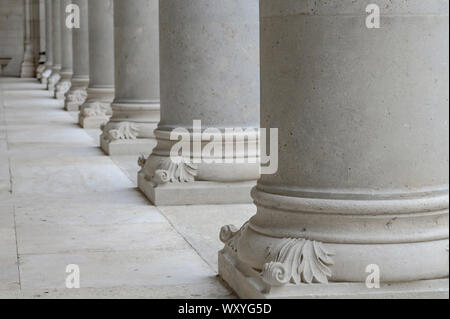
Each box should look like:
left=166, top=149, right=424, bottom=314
left=138, top=172, right=256, bottom=206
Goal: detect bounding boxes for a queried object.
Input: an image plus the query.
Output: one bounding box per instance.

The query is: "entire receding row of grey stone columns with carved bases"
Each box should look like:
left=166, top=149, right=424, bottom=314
left=18, top=0, right=449, bottom=297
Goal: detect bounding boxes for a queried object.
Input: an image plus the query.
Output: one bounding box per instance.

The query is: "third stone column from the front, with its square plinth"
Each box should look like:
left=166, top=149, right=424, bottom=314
left=100, top=0, right=160, bottom=156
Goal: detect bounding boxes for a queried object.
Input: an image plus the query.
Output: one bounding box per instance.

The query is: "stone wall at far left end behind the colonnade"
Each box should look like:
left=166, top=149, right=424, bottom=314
left=0, top=0, right=24, bottom=76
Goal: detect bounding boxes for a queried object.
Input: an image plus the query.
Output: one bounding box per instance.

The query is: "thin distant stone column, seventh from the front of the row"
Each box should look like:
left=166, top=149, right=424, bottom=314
left=48, top=0, right=62, bottom=95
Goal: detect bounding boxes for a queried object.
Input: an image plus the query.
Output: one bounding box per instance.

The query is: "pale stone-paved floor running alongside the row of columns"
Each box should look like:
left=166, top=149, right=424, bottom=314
left=0, top=78, right=256, bottom=298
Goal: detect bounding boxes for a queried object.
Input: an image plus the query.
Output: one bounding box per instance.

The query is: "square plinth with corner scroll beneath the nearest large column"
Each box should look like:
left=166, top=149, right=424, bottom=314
left=219, top=248, right=449, bottom=299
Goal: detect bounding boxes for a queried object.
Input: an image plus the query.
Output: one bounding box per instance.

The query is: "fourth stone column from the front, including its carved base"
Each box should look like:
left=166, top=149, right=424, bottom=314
left=79, top=0, right=114, bottom=128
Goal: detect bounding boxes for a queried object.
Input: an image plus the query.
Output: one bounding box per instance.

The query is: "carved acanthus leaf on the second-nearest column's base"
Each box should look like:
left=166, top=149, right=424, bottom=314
left=151, top=157, right=197, bottom=184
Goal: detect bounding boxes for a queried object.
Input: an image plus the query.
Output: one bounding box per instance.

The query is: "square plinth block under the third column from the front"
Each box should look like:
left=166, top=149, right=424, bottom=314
left=100, top=134, right=156, bottom=156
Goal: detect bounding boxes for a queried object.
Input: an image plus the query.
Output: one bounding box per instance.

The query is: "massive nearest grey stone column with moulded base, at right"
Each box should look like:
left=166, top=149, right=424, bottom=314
left=219, top=0, right=449, bottom=298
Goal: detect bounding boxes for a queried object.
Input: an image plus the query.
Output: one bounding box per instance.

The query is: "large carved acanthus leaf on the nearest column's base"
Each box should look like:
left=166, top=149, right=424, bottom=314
left=262, top=238, right=333, bottom=286
